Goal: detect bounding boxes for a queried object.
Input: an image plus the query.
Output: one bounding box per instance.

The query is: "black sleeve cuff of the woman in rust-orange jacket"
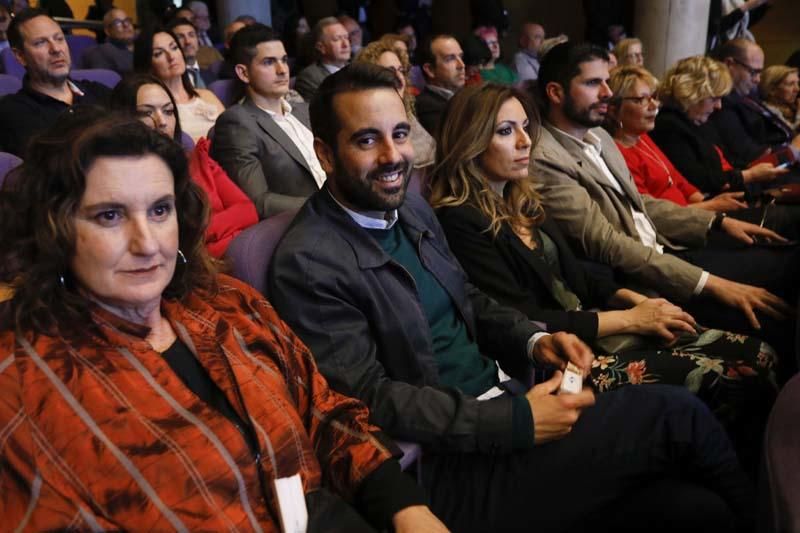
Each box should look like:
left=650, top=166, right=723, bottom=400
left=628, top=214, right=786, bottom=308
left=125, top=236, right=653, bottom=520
left=354, top=459, right=428, bottom=530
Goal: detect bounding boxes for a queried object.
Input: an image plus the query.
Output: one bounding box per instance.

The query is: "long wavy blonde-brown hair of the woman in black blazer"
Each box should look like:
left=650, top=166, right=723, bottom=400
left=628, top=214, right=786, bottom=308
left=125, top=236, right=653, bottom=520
left=430, top=83, right=544, bottom=236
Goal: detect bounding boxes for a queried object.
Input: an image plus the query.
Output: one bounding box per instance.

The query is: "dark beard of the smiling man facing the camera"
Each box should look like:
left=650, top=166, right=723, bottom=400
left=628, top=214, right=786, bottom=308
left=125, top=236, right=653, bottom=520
left=334, top=158, right=411, bottom=211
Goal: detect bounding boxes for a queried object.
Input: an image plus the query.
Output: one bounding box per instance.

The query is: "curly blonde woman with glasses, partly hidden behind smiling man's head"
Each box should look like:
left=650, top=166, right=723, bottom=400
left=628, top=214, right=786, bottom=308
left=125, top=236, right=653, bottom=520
left=354, top=39, right=436, bottom=168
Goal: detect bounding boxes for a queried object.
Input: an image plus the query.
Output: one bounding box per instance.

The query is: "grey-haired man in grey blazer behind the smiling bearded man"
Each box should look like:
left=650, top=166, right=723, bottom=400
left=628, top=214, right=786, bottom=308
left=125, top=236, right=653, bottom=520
left=294, top=17, right=350, bottom=102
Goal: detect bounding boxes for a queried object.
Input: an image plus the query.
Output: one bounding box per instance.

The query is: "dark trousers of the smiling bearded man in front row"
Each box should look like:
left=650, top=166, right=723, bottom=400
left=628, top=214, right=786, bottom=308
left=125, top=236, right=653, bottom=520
left=423, top=385, right=754, bottom=532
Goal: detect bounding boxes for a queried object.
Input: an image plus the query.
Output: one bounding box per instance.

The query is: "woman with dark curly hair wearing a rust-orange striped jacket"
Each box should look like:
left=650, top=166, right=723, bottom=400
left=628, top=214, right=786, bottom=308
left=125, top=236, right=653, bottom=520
left=0, top=110, right=442, bottom=531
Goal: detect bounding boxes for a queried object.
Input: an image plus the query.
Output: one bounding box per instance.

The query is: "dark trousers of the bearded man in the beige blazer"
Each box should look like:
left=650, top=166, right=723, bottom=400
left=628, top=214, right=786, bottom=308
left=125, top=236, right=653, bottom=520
left=671, top=235, right=800, bottom=382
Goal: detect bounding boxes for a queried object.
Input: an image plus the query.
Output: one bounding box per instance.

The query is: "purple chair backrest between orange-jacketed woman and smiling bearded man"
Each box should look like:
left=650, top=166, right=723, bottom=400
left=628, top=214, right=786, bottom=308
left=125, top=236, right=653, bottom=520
left=225, top=210, right=297, bottom=296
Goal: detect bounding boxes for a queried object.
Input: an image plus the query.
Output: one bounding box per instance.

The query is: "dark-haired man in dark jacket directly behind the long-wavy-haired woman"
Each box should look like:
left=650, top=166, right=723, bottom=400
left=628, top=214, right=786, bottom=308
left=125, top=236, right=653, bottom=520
left=416, top=34, right=465, bottom=135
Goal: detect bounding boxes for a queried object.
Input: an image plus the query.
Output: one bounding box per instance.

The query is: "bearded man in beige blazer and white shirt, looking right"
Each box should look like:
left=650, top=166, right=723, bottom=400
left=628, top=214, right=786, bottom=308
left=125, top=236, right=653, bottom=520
left=532, top=43, right=798, bottom=366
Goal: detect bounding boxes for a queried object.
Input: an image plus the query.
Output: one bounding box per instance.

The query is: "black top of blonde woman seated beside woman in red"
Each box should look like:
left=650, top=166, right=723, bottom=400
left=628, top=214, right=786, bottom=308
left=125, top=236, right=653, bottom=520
left=650, top=105, right=744, bottom=194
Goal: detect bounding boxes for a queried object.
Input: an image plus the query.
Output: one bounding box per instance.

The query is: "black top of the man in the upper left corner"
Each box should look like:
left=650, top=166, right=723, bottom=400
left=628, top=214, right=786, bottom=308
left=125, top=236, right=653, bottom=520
left=0, top=76, right=111, bottom=159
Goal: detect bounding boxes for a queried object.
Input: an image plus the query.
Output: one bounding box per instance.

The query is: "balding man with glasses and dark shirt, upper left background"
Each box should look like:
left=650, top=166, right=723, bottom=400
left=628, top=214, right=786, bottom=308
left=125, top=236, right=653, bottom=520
left=80, top=7, right=136, bottom=74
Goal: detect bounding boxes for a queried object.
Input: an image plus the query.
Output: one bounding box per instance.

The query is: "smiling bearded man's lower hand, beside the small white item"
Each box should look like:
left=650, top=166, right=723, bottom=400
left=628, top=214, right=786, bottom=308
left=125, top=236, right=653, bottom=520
left=525, top=370, right=594, bottom=444
